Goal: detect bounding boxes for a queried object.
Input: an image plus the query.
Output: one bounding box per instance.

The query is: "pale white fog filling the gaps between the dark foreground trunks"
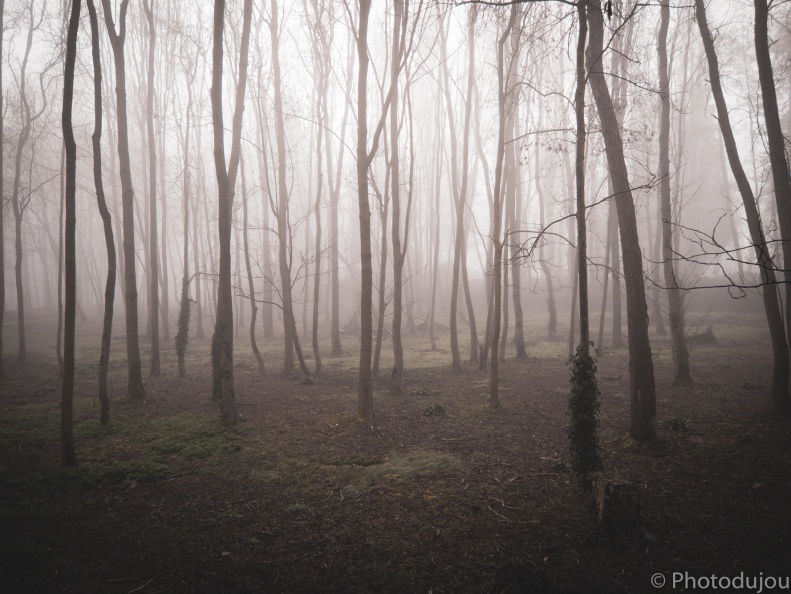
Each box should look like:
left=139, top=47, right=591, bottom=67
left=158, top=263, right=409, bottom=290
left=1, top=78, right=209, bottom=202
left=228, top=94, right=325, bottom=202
left=3, top=0, right=791, bottom=402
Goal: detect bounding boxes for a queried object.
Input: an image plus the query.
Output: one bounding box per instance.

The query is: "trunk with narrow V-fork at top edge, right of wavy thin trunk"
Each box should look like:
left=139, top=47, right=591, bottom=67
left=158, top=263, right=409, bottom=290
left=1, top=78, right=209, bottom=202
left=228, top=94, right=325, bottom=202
left=102, top=0, right=146, bottom=403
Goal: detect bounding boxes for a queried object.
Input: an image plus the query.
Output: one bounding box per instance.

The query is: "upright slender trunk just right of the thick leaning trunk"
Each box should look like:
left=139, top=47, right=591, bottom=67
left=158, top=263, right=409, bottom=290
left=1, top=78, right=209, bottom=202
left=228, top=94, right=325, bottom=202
left=657, top=4, right=692, bottom=382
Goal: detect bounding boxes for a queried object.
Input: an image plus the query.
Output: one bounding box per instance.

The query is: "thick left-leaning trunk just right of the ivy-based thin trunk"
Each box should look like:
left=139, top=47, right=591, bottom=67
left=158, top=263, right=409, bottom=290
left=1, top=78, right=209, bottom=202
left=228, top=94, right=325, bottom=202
left=586, top=0, right=656, bottom=441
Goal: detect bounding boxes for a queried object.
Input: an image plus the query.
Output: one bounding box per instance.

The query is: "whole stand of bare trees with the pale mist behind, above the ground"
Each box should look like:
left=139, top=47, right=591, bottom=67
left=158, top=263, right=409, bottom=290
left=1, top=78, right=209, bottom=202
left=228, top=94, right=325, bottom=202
left=0, top=0, right=791, bottom=464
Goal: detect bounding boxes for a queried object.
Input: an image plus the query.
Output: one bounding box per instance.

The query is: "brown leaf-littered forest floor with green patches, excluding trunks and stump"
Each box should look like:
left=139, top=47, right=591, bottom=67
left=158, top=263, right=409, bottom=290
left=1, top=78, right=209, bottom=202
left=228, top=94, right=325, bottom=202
left=0, top=314, right=791, bottom=594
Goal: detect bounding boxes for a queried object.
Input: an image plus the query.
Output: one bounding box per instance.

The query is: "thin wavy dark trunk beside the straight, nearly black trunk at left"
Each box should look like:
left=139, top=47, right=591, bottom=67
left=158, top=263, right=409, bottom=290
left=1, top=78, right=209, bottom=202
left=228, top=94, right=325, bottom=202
left=88, top=0, right=117, bottom=425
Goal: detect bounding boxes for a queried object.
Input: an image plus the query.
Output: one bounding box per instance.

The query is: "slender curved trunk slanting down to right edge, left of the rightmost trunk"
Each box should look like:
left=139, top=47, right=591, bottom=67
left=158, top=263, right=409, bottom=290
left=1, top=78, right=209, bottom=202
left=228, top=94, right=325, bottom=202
left=695, top=0, right=791, bottom=412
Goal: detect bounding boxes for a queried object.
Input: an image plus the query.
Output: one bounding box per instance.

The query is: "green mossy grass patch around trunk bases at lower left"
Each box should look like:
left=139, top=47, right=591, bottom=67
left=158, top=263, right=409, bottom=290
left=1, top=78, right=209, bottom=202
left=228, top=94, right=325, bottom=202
left=0, top=398, right=245, bottom=516
